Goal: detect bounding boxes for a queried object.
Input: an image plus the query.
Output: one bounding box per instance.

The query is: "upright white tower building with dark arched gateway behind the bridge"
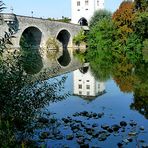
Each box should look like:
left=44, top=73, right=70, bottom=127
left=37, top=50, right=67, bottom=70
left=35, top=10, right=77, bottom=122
left=71, top=0, right=104, bottom=26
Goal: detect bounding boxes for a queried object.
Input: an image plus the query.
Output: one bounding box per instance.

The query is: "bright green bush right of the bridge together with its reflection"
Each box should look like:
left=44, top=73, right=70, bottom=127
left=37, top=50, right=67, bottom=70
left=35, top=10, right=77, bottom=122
left=86, top=18, right=116, bottom=80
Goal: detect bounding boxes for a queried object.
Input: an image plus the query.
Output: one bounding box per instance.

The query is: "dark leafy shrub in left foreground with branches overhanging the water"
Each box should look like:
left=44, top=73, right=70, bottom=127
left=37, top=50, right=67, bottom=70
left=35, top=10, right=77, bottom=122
left=0, top=48, right=66, bottom=147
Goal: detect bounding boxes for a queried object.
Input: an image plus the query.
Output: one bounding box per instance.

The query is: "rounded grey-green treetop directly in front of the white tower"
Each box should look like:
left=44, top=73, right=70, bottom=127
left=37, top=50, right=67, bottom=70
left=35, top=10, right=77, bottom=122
left=90, top=9, right=112, bottom=27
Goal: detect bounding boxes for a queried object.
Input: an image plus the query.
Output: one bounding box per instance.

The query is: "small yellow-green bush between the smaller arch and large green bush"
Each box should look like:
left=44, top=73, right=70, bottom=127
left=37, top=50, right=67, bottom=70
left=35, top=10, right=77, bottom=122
left=73, top=30, right=86, bottom=45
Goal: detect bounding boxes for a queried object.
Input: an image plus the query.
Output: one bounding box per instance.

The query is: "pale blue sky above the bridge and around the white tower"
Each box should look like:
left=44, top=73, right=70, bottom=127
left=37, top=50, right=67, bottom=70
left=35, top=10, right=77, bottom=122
left=3, top=0, right=123, bottom=18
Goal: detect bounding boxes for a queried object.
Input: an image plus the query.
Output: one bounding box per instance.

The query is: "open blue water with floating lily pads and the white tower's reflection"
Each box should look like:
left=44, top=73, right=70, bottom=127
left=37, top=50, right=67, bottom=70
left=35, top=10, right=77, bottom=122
left=33, top=68, right=148, bottom=148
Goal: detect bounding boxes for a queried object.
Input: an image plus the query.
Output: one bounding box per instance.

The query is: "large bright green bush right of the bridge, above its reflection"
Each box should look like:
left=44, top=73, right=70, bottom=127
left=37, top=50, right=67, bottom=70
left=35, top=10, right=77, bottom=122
left=87, top=18, right=116, bottom=60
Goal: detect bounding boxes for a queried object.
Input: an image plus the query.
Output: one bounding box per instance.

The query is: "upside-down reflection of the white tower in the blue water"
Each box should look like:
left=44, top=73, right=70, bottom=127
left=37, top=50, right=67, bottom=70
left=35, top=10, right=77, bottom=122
left=73, top=67, right=105, bottom=99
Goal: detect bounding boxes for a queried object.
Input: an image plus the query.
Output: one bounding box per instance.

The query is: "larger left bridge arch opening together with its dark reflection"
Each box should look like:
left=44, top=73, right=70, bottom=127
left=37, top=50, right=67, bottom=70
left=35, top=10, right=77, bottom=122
left=19, top=27, right=43, bottom=74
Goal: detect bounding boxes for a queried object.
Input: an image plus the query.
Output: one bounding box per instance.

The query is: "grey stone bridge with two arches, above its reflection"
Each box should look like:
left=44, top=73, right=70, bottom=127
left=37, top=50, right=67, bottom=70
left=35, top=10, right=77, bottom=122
left=0, top=13, right=81, bottom=48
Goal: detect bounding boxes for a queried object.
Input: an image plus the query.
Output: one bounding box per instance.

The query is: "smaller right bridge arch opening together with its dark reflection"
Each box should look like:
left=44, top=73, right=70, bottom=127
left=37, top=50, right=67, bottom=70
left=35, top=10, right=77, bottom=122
left=57, top=29, right=71, bottom=66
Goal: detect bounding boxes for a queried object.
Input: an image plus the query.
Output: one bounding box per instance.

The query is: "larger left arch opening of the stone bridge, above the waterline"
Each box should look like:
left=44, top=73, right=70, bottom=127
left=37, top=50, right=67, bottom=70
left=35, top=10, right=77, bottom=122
left=19, top=26, right=42, bottom=47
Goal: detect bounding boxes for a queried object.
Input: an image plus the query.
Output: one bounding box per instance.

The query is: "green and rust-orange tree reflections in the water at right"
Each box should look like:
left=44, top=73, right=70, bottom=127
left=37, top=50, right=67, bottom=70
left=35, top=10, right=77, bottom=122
left=90, top=49, right=148, bottom=118
